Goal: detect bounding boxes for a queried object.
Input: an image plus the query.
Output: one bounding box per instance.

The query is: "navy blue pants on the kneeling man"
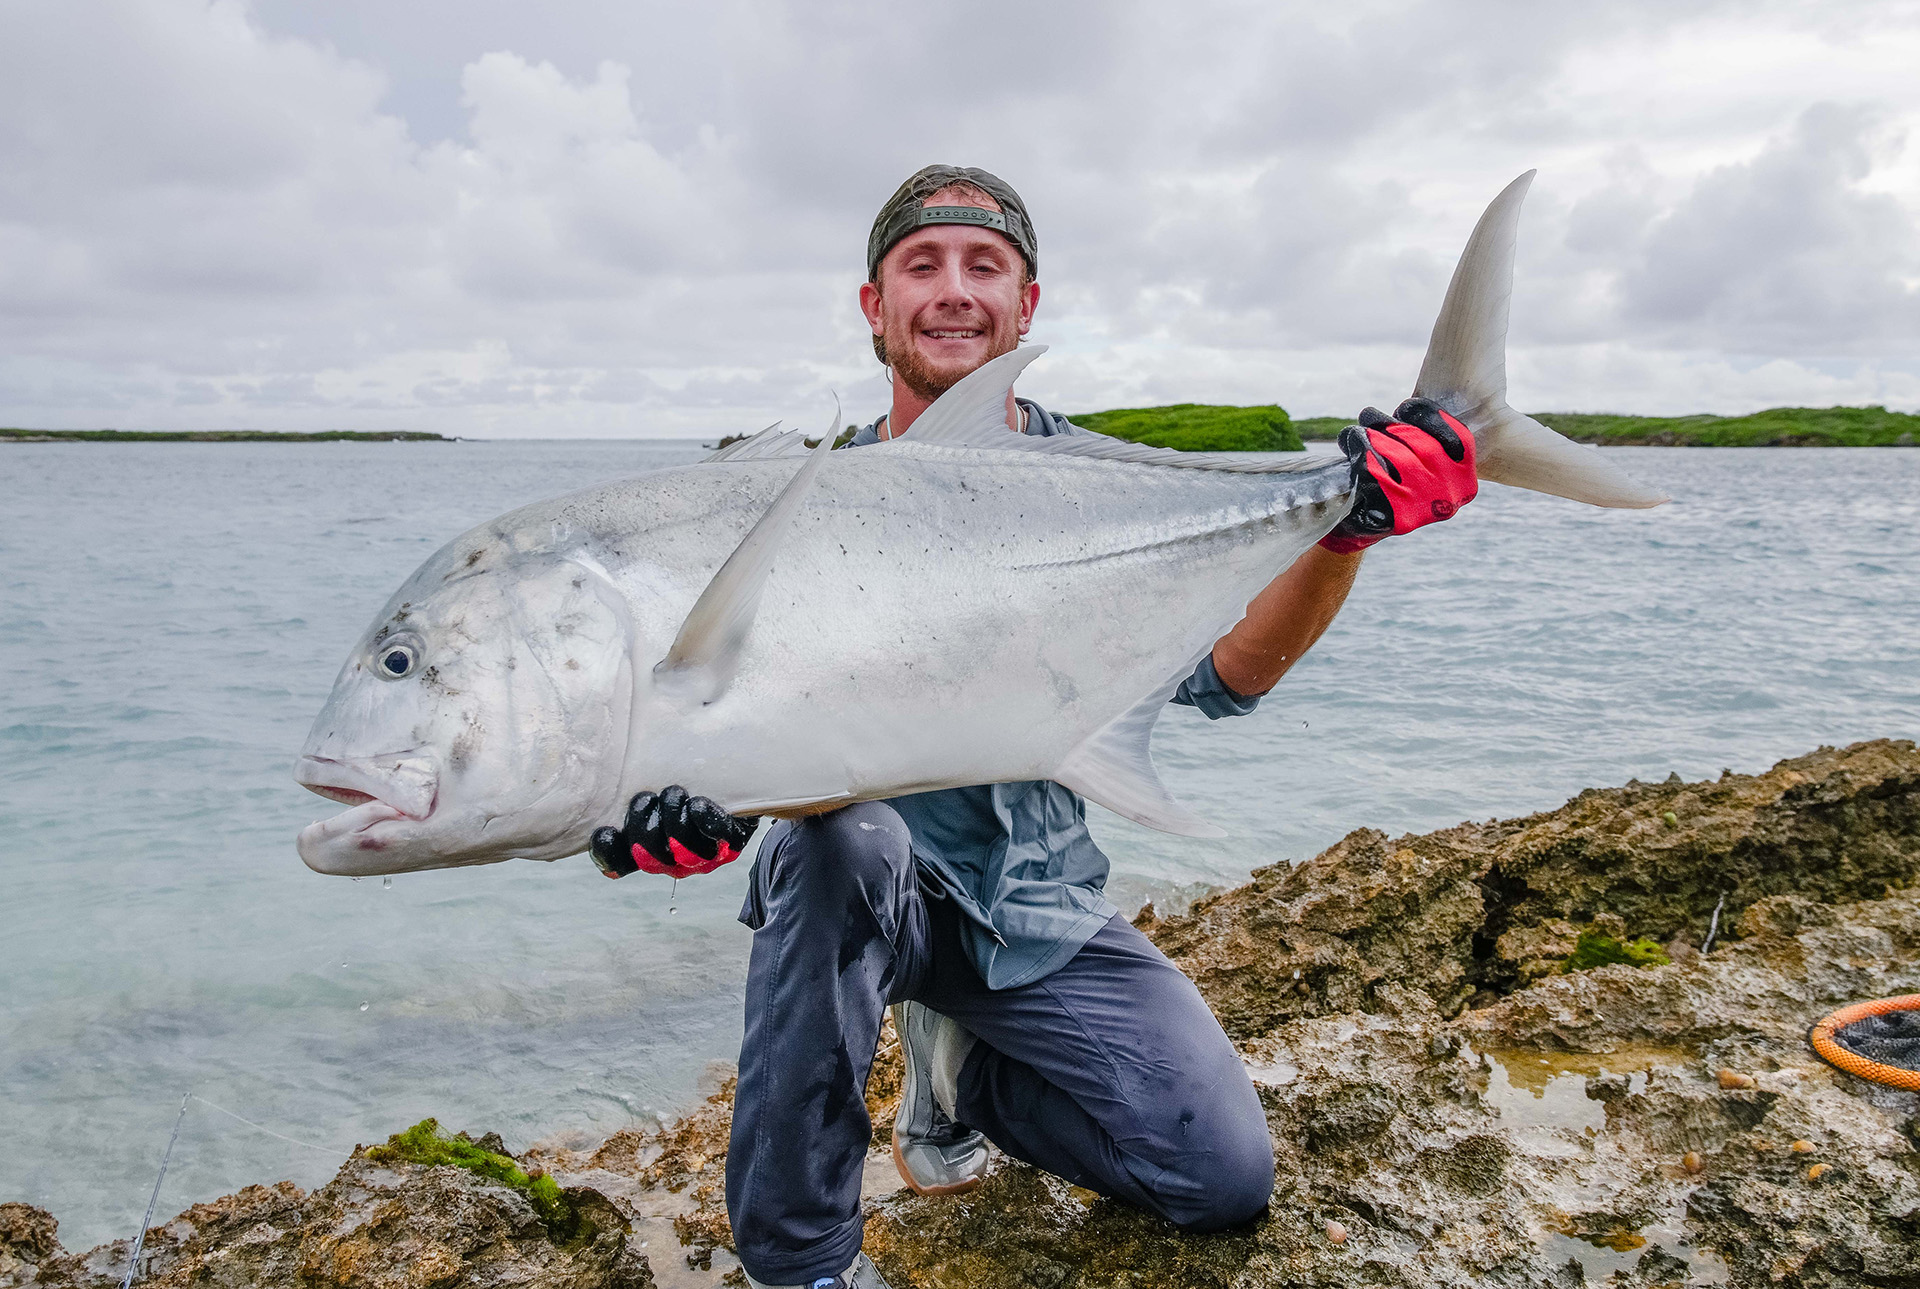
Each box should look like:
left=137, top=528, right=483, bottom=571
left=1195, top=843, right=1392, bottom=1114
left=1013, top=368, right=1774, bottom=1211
left=726, top=803, right=1273, bottom=1283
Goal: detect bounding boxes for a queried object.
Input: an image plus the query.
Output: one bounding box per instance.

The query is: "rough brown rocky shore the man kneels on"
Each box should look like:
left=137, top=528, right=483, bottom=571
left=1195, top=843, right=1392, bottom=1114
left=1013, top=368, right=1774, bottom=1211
left=0, top=740, right=1920, bottom=1289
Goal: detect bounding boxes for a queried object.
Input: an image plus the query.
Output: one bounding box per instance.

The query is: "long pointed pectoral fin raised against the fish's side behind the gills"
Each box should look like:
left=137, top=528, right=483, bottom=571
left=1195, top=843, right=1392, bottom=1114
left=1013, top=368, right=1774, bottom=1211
left=653, top=428, right=839, bottom=703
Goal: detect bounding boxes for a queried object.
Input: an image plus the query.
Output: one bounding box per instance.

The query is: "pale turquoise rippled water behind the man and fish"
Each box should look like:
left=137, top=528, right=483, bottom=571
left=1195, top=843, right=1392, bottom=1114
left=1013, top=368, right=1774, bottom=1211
left=0, top=442, right=1920, bottom=1247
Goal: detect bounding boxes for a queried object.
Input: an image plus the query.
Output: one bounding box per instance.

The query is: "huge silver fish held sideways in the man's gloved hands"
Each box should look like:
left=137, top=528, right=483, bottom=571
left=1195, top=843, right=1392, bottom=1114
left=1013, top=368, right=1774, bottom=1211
left=296, top=171, right=1665, bottom=874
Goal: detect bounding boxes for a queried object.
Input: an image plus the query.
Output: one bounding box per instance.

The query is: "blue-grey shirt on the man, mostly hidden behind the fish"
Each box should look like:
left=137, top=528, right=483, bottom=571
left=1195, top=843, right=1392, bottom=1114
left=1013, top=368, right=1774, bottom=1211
left=741, top=398, right=1260, bottom=989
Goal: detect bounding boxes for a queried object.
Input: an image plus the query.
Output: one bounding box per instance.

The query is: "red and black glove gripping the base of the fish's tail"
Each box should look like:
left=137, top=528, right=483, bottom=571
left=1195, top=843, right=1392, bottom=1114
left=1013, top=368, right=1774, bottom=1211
left=1321, top=398, right=1480, bottom=555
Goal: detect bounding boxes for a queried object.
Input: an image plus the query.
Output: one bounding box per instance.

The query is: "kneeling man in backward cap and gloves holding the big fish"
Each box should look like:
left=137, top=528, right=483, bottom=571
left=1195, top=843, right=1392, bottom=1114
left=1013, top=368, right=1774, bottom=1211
left=593, top=165, right=1476, bottom=1289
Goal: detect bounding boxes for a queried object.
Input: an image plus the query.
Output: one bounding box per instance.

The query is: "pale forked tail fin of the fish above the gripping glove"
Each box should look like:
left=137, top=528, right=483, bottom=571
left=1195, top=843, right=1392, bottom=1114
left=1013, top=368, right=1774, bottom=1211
left=1413, top=171, right=1668, bottom=507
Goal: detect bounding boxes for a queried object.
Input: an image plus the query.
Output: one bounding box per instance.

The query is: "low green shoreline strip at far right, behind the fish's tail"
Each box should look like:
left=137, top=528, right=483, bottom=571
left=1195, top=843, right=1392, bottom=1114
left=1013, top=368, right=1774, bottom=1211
left=1294, top=407, right=1920, bottom=448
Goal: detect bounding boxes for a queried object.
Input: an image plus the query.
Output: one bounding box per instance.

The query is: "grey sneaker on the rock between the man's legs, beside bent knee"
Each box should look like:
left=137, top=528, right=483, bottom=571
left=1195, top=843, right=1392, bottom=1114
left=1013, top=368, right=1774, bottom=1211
left=893, top=1003, right=987, bottom=1195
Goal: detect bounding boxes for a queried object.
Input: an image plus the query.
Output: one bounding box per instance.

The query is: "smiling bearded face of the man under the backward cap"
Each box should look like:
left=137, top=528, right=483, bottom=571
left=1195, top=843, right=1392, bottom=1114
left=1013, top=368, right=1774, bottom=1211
left=860, top=192, right=1041, bottom=401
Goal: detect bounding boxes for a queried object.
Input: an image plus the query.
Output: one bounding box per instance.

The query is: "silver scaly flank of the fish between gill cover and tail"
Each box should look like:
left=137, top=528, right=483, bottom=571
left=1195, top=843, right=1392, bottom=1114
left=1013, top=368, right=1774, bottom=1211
left=568, top=440, right=1350, bottom=807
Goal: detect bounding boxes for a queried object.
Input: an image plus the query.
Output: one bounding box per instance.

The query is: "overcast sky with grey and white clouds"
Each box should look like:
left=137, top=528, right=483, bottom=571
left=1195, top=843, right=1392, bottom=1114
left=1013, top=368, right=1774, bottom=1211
left=0, top=0, right=1920, bottom=436
